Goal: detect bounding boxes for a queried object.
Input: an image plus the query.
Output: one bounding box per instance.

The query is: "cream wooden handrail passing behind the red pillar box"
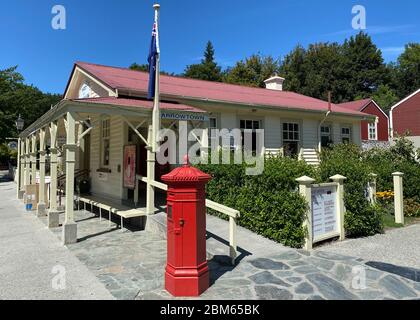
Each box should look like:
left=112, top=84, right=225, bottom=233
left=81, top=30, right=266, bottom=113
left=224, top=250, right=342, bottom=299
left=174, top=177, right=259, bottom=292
left=135, top=174, right=241, bottom=265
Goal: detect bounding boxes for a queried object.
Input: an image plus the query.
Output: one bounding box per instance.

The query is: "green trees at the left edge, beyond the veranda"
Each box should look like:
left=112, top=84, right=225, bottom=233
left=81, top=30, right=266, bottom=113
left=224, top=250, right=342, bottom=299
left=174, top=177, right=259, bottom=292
left=0, top=66, right=61, bottom=143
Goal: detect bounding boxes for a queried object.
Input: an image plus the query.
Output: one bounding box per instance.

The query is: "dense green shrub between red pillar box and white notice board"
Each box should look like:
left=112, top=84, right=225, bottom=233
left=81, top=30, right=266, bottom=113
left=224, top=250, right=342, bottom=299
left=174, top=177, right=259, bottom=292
left=198, top=157, right=317, bottom=248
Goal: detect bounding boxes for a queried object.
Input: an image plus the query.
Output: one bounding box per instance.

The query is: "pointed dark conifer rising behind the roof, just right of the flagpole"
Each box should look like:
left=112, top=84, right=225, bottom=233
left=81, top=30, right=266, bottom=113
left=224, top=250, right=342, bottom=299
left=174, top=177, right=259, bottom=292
left=184, top=41, right=222, bottom=81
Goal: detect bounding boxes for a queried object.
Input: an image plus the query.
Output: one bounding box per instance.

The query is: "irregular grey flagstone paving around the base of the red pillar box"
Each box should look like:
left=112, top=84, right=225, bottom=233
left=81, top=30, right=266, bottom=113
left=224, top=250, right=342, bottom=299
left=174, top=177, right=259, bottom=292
left=36, top=206, right=420, bottom=300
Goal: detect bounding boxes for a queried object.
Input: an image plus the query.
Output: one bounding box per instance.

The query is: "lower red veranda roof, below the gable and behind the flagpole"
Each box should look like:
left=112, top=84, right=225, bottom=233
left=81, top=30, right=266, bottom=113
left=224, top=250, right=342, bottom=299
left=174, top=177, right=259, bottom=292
left=72, top=97, right=205, bottom=113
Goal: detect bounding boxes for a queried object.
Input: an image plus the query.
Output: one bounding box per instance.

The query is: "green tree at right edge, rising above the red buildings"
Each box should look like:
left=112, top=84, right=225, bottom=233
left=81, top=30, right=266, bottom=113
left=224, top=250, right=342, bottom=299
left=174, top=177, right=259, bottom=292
left=396, top=43, right=420, bottom=99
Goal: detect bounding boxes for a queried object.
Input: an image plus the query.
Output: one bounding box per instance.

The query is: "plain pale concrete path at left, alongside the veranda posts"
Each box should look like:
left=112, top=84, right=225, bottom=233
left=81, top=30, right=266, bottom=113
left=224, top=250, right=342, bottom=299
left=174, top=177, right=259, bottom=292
left=0, top=182, right=114, bottom=300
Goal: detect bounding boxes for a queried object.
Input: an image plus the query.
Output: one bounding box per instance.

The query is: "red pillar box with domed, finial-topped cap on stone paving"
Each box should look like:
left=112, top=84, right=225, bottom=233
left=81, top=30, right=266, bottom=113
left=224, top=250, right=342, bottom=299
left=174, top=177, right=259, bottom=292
left=162, top=159, right=211, bottom=297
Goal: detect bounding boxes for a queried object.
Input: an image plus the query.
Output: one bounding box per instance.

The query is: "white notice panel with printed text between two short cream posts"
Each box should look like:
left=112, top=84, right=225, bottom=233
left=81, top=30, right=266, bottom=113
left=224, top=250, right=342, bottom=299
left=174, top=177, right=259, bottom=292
left=312, top=186, right=338, bottom=241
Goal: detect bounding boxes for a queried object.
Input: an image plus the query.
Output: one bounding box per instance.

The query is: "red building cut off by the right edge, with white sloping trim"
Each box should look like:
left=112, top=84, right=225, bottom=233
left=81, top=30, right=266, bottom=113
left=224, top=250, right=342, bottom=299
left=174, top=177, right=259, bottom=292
left=390, top=89, right=420, bottom=147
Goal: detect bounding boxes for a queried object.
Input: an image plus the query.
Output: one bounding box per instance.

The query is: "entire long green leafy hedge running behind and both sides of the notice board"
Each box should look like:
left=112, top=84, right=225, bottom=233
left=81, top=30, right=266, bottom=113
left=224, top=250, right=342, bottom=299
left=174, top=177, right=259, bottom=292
left=198, top=139, right=420, bottom=248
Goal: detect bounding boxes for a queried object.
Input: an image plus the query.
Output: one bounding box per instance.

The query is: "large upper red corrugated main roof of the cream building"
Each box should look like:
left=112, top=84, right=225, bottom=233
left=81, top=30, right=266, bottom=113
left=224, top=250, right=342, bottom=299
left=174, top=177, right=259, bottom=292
left=76, top=62, right=366, bottom=116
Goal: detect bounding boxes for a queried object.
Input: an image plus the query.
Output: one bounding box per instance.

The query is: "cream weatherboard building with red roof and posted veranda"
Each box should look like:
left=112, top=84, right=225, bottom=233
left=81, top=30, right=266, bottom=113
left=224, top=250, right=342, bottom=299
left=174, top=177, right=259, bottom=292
left=17, top=62, right=375, bottom=243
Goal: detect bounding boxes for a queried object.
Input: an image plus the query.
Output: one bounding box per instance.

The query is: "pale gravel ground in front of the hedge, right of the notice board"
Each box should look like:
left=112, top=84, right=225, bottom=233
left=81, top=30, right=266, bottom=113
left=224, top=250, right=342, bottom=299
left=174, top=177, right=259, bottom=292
left=316, top=224, right=420, bottom=269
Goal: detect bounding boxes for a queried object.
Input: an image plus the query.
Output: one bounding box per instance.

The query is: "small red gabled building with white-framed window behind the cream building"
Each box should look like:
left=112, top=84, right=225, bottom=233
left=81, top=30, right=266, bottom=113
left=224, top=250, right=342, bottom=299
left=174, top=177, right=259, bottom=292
left=339, top=99, right=389, bottom=142
